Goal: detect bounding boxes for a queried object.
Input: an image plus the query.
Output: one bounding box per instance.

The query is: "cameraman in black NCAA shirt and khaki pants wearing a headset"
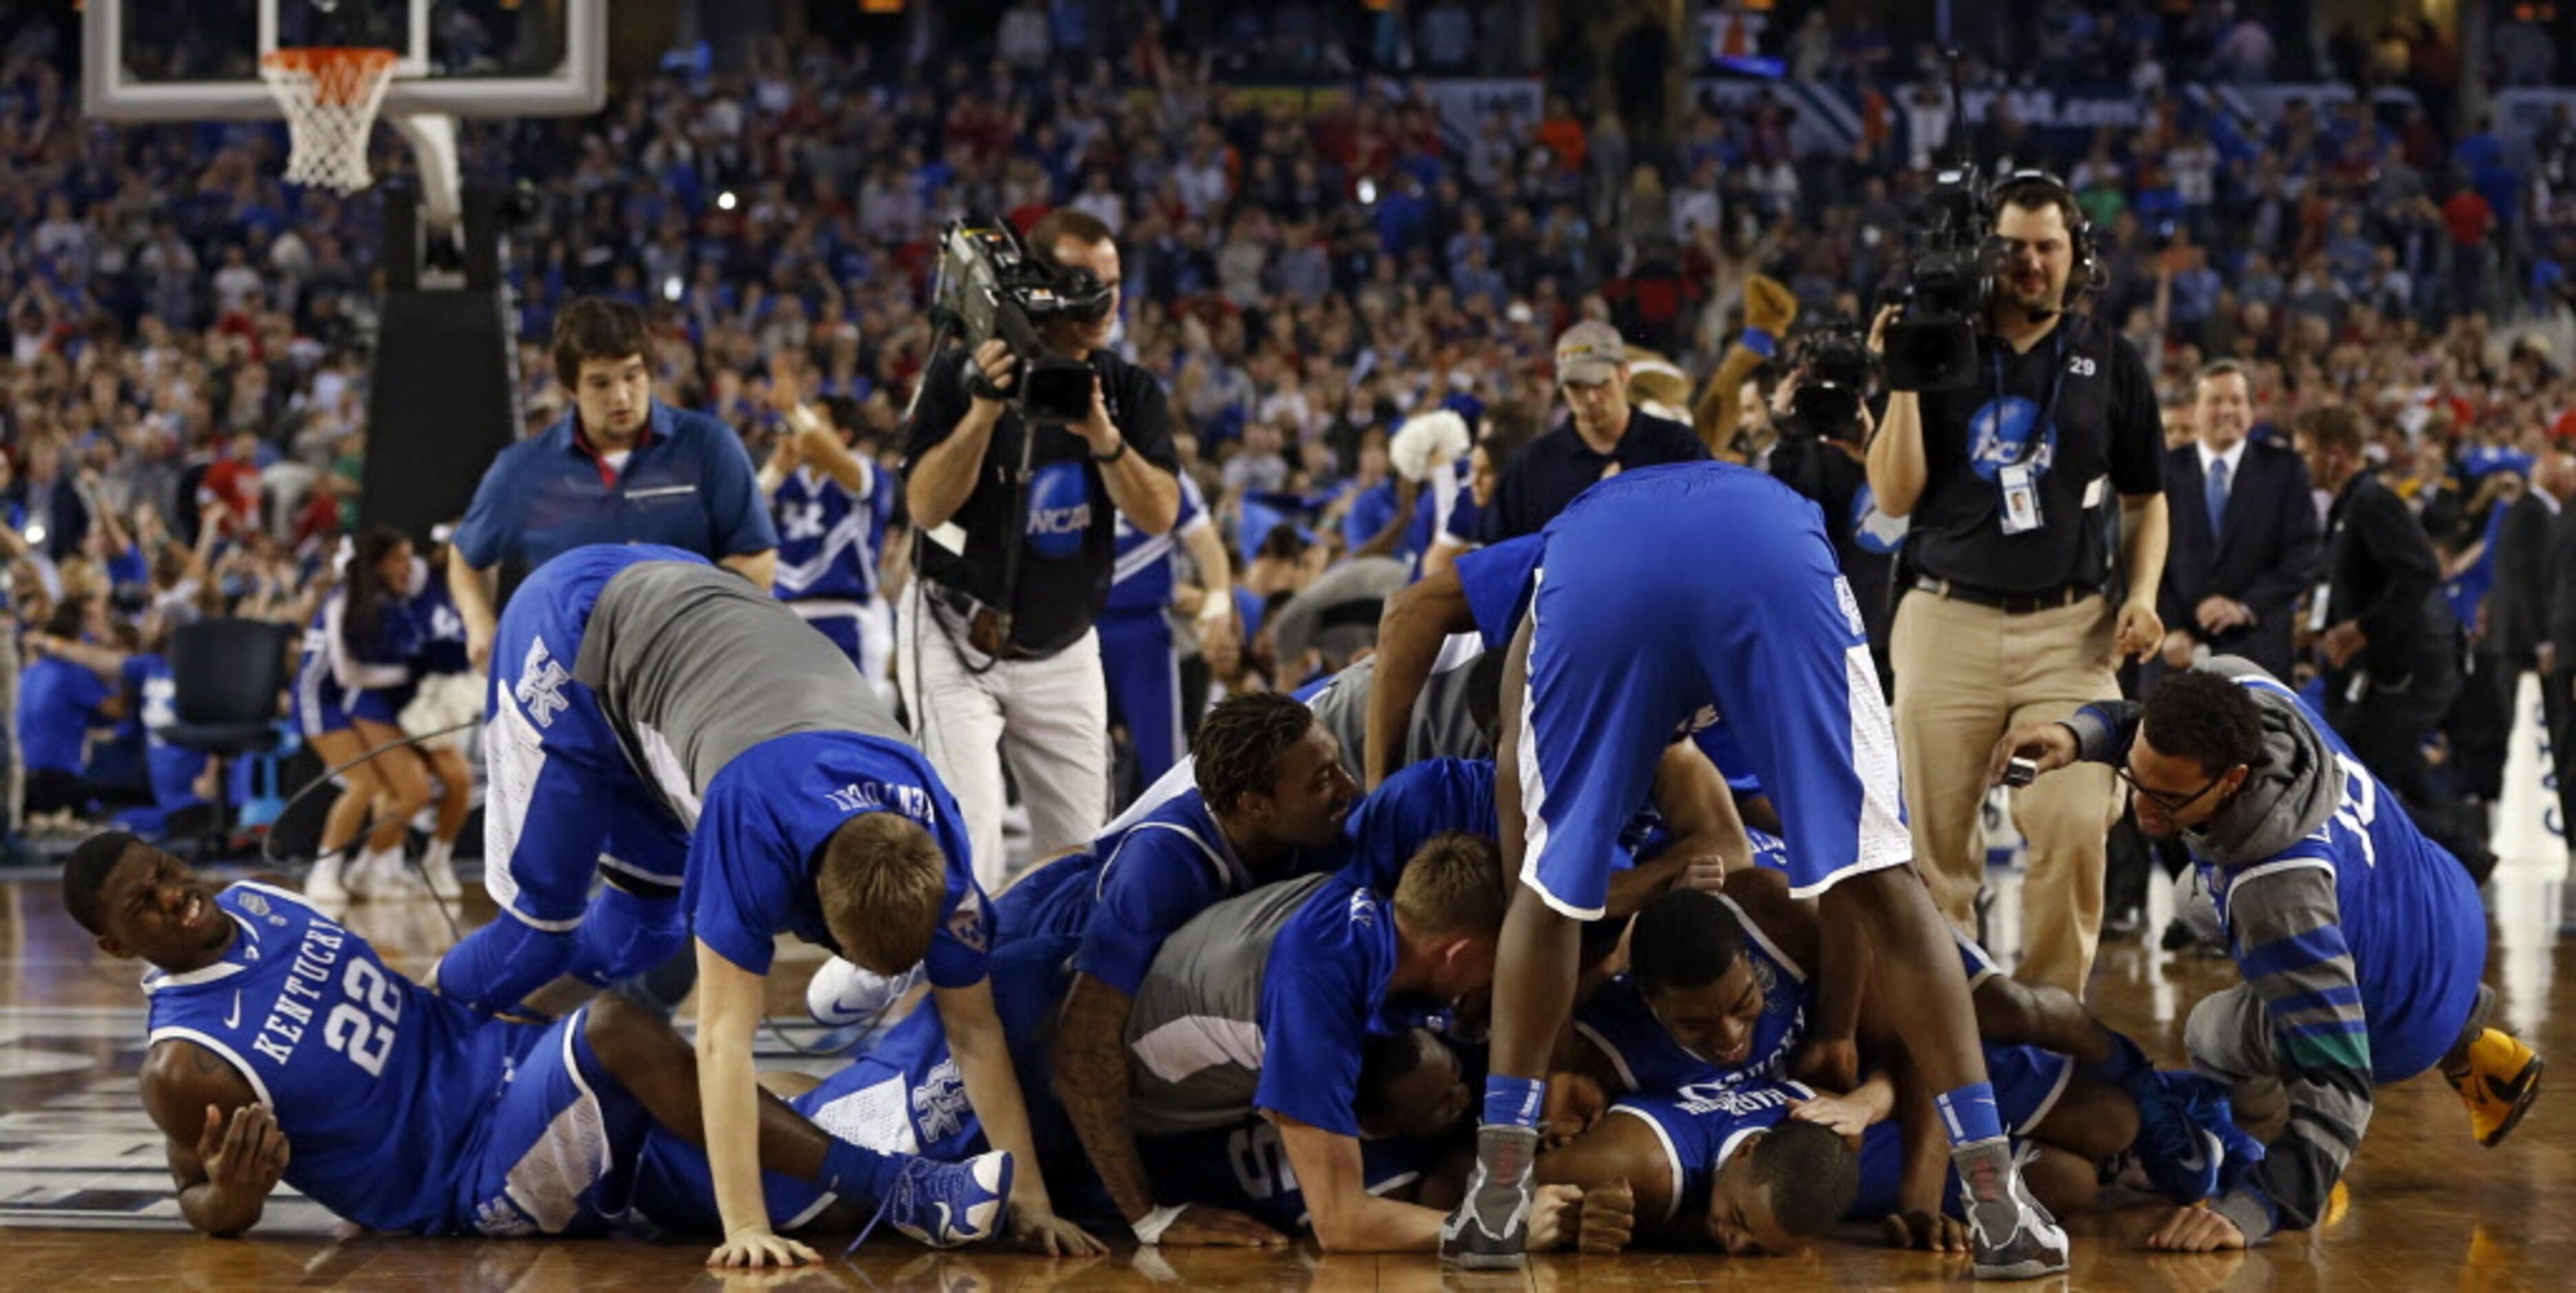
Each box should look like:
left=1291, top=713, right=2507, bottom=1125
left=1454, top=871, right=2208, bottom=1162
left=1867, top=173, right=2166, bottom=994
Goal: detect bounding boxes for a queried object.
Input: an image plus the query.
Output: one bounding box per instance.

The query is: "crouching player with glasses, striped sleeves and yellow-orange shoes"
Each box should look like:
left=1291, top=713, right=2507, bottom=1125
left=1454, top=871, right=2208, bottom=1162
left=1994, top=657, right=2540, bottom=1252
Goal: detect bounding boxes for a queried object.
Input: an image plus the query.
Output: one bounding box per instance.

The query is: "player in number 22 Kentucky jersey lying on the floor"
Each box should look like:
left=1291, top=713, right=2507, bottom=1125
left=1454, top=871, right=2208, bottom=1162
left=62, top=832, right=1015, bottom=1247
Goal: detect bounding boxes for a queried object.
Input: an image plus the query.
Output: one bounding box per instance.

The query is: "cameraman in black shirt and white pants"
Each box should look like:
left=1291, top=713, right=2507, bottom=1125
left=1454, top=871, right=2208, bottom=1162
left=897, top=209, right=1180, bottom=889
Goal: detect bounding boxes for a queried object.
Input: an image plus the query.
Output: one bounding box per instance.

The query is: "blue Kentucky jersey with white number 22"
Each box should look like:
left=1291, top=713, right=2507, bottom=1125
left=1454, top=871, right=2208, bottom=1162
left=144, top=883, right=523, bottom=1234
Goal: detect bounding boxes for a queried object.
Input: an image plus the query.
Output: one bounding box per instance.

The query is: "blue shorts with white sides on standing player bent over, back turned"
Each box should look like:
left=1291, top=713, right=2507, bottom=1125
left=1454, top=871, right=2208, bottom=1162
left=1507, top=463, right=1914, bottom=920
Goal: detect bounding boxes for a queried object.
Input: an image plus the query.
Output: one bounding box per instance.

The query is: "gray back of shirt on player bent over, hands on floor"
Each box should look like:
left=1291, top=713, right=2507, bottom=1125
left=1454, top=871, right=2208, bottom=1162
left=572, top=562, right=912, bottom=827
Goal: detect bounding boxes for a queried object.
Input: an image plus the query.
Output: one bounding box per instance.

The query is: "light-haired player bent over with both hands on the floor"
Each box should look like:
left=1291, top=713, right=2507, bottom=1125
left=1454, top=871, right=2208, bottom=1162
left=432, top=543, right=1082, bottom=1265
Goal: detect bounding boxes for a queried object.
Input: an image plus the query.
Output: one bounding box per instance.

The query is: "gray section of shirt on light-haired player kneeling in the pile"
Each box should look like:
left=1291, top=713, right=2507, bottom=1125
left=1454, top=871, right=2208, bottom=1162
left=1126, top=876, right=1332, bottom=1136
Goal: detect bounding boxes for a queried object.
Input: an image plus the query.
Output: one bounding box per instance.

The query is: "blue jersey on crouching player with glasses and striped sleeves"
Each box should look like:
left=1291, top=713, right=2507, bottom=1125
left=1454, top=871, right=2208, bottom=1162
left=2200, top=677, right=2486, bottom=1082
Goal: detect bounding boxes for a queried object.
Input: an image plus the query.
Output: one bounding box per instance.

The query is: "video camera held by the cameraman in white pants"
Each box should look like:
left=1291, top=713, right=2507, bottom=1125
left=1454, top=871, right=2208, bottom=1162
left=930, top=216, right=1116, bottom=425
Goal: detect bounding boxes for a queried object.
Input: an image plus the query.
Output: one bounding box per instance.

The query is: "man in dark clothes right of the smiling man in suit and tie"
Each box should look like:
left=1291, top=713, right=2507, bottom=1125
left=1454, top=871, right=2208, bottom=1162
left=2298, top=404, right=2496, bottom=881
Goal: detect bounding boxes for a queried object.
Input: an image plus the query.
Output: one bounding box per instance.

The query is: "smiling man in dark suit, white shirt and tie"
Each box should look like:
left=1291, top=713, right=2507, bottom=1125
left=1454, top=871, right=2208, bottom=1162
left=2146, top=358, right=2321, bottom=685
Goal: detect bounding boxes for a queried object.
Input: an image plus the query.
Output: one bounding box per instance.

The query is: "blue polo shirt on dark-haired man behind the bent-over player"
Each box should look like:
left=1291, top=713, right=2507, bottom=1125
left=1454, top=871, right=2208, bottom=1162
left=456, top=399, right=778, bottom=569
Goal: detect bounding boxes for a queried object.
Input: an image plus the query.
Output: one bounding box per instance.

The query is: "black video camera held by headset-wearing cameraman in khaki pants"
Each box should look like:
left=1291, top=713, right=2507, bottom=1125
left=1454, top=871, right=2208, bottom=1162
left=1885, top=165, right=2004, bottom=392
